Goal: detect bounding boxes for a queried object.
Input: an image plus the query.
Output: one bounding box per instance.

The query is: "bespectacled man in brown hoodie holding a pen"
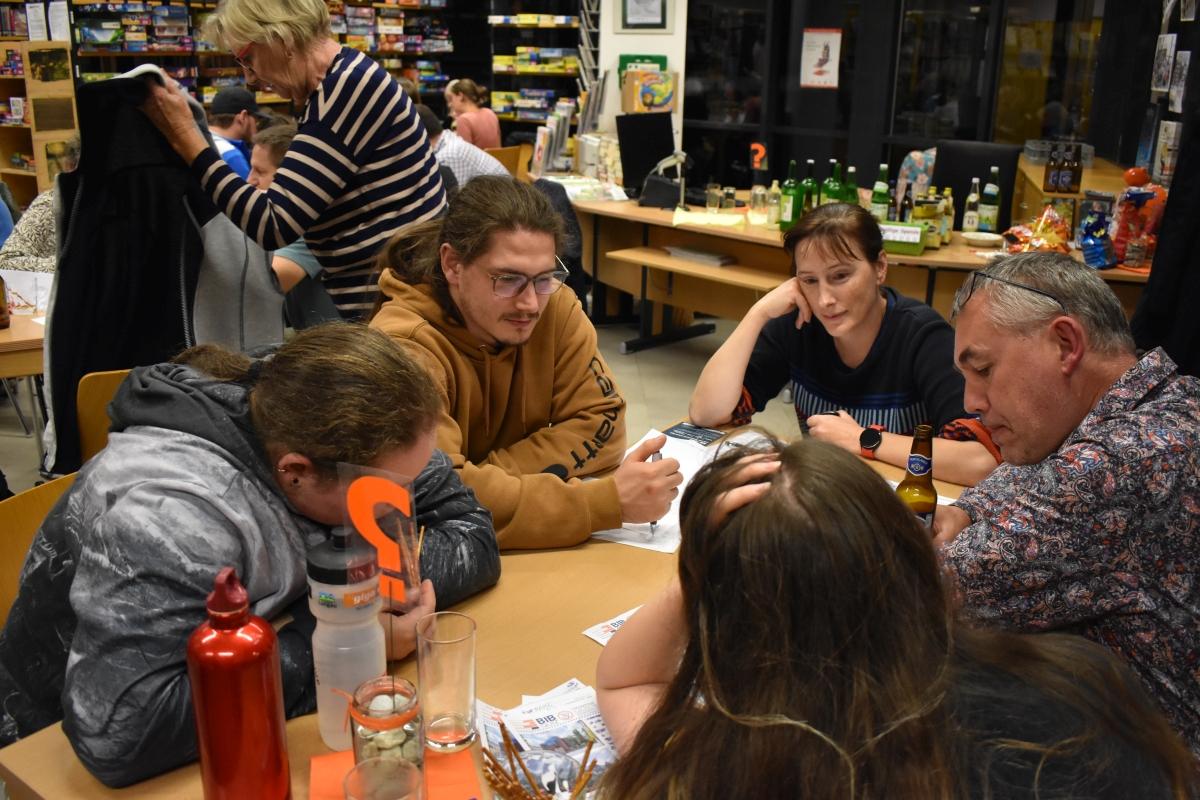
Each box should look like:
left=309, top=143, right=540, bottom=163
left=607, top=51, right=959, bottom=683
left=371, top=175, right=683, bottom=549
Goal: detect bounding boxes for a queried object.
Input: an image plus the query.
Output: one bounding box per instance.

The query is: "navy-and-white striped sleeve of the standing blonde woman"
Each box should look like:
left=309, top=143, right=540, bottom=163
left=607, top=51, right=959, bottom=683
left=192, top=52, right=419, bottom=249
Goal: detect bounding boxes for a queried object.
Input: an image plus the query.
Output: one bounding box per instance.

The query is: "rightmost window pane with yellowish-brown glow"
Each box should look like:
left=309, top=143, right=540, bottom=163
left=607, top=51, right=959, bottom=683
left=995, top=0, right=1104, bottom=144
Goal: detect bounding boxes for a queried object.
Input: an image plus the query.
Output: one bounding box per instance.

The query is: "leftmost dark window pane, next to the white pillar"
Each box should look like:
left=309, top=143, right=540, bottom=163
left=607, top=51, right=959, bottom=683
left=683, top=0, right=767, bottom=124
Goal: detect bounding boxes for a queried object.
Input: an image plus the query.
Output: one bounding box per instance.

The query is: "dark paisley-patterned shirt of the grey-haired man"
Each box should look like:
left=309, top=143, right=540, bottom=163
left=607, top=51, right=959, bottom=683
left=942, top=349, right=1200, bottom=757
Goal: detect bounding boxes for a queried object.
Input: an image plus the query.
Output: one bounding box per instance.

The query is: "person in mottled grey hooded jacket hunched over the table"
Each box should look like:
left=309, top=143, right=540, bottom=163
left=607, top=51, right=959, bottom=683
left=0, top=323, right=500, bottom=787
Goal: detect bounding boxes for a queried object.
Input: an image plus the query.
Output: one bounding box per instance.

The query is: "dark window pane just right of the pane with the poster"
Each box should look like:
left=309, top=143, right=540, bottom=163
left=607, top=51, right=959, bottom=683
left=892, top=0, right=989, bottom=140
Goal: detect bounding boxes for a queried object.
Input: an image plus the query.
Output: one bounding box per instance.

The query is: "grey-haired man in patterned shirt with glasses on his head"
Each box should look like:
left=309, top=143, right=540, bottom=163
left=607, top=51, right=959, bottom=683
left=934, top=253, right=1200, bottom=757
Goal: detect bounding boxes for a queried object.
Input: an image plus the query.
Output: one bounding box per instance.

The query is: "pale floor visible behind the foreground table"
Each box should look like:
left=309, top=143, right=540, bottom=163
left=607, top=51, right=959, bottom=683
left=0, top=320, right=796, bottom=492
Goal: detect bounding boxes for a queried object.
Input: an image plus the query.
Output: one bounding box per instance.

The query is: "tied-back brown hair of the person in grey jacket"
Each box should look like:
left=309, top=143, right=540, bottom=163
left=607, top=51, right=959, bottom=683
left=173, top=323, right=442, bottom=476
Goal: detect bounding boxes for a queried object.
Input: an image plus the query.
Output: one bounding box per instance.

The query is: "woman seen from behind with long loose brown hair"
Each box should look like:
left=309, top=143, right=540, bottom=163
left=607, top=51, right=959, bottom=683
left=596, top=440, right=1195, bottom=800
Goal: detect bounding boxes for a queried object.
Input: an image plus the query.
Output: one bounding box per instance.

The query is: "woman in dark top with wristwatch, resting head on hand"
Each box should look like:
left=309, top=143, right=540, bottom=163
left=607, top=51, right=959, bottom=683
left=688, top=203, right=1000, bottom=485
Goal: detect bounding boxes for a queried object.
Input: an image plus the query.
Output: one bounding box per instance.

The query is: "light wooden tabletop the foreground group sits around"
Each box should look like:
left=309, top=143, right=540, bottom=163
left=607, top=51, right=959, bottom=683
left=0, top=462, right=961, bottom=800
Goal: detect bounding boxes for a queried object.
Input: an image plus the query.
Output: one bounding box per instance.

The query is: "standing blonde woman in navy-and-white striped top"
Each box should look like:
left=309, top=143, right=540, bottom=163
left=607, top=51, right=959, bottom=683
left=143, top=0, right=445, bottom=315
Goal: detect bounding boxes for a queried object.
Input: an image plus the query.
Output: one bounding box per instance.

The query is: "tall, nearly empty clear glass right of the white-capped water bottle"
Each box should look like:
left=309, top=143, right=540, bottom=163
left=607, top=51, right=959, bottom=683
left=416, top=612, right=475, bottom=752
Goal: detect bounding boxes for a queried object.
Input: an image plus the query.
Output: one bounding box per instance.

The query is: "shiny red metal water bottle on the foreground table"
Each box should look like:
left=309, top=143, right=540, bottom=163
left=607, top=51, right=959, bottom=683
left=187, top=566, right=292, bottom=800
